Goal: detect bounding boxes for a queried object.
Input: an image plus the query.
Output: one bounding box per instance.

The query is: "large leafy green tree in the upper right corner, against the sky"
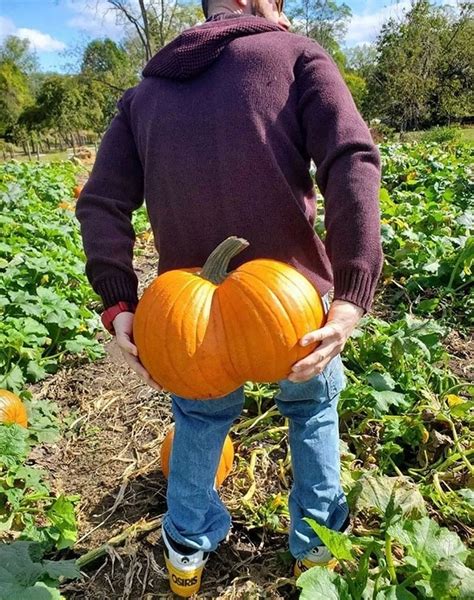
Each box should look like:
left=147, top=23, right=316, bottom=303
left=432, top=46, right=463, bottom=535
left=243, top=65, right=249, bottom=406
left=365, top=0, right=474, bottom=131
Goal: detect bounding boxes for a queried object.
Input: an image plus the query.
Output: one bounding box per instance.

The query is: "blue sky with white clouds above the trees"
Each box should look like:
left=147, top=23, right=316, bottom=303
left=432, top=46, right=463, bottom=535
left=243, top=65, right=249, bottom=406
left=0, top=0, right=448, bottom=71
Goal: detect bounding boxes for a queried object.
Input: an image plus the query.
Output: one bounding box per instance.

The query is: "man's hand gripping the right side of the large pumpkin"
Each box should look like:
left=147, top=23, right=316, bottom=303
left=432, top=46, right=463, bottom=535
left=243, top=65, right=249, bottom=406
left=288, top=300, right=364, bottom=383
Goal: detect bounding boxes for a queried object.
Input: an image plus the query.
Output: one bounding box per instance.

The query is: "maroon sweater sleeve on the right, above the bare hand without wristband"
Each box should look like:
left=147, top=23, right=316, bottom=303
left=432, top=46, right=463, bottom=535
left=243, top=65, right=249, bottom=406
left=297, top=43, right=383, bottom=312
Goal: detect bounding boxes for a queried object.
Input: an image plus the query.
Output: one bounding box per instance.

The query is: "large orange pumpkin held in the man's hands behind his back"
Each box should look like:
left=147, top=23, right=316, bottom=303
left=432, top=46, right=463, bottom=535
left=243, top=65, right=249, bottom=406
left=133, top=237, right=325, bottom=399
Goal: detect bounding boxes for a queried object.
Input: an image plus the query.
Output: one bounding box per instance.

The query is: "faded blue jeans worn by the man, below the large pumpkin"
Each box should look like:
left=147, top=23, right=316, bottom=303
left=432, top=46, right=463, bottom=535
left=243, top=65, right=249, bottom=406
left=164, top=297, right=349, bottom=559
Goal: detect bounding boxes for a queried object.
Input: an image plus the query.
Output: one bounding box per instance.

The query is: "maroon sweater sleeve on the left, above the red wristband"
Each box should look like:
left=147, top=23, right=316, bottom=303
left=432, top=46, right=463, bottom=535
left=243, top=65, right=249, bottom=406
left=76, top=89, right=143, bottom=308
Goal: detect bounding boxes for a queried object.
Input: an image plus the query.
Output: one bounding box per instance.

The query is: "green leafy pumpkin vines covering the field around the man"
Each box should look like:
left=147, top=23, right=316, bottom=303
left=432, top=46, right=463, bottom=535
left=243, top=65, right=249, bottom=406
left=0, top=144, right=474, bottom=600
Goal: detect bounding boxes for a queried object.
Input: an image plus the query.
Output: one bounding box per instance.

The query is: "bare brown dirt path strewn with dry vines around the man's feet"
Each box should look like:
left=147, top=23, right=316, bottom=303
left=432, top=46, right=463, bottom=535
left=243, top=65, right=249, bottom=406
left=33, top=240, right=473, bottom=600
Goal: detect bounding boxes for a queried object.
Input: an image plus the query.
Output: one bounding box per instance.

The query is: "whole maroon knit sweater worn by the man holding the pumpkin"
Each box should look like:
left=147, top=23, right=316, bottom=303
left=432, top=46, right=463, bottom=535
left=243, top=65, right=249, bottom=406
left=76, top=15, right=382, bottom=311
